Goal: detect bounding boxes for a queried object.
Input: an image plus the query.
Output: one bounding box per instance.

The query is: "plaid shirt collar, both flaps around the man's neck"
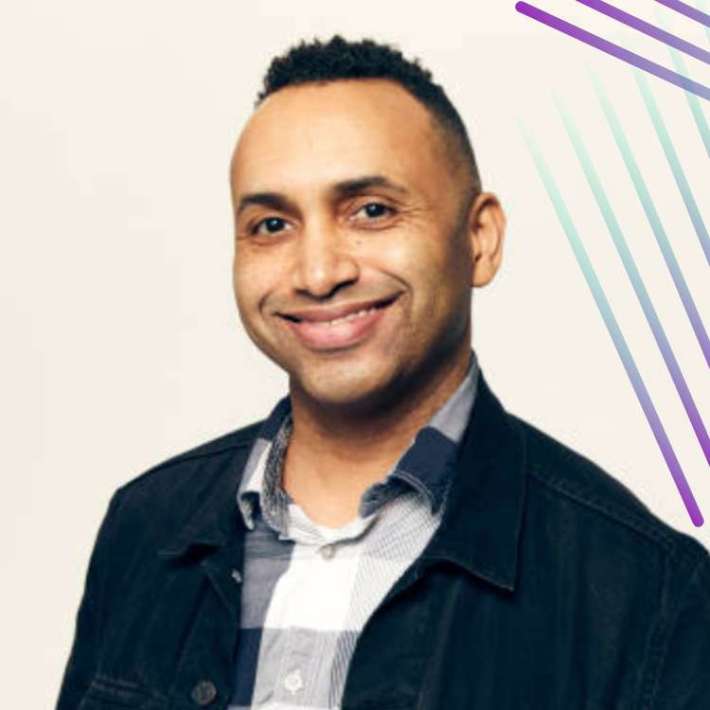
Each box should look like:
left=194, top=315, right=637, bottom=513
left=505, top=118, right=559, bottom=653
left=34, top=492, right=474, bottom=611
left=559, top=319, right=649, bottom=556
left=237, top=350, right=479, bottom=534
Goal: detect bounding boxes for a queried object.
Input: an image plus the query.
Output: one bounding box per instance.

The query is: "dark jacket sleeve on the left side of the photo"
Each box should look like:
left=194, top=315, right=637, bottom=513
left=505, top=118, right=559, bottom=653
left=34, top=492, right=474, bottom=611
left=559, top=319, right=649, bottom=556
left=56, top=491, right=124, bottom=710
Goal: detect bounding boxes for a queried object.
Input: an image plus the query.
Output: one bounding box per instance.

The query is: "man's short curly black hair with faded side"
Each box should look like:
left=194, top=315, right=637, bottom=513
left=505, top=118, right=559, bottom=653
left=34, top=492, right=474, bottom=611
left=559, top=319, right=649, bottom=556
left=256, top=35, right=481, bottom=197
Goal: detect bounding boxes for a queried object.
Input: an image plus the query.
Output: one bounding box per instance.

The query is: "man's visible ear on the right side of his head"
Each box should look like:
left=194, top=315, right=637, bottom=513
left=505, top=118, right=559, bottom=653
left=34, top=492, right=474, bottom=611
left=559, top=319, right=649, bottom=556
left=468, top=192, right=506, bottom=286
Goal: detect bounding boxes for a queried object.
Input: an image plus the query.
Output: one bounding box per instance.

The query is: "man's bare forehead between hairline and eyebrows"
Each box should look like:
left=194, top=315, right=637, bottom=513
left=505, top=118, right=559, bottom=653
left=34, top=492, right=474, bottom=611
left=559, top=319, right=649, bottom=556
left=232, top=79, right=447, bottom=191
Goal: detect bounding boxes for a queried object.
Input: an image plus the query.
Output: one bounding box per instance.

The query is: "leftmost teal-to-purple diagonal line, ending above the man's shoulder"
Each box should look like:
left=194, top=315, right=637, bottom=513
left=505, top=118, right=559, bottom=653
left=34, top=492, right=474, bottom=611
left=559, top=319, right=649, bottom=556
left=520, top=124, right=704, bottom=527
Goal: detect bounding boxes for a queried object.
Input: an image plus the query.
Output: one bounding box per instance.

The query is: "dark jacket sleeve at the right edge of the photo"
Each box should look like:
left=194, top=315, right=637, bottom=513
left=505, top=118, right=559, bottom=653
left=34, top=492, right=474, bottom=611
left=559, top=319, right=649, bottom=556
left=652, top=552, right=710, bottom=710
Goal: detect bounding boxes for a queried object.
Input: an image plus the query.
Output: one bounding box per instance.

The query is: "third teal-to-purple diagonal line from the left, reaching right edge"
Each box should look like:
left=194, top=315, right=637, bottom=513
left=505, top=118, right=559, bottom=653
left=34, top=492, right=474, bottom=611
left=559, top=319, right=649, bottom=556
left=592, top=76, right=710, bottom=367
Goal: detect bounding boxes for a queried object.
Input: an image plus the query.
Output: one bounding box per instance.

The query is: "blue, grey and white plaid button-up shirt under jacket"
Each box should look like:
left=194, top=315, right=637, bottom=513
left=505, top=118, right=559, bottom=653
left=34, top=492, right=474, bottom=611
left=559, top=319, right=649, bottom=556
left=229, top=351, right=478, bottom=710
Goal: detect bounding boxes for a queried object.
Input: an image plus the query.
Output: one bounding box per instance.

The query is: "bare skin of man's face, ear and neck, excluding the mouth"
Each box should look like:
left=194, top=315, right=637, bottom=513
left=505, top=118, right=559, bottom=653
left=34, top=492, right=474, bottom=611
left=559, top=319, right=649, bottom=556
left=231, top=79, right=505, bottom=526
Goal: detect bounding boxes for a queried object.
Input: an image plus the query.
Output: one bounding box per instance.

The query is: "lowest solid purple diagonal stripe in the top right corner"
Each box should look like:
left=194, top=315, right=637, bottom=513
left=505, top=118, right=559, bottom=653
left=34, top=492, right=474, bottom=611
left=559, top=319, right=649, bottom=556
left=515, top=2, right=710, bottom=101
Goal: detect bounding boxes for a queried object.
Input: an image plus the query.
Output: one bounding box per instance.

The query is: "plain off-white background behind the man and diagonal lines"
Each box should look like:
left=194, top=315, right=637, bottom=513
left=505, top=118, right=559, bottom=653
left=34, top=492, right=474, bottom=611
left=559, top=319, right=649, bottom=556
left=0, top=0, right=710, bottom=708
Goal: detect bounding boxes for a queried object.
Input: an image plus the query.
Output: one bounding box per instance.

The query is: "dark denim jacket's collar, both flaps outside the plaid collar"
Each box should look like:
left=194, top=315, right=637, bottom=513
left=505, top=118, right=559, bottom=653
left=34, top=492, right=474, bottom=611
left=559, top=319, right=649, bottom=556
left=157, top=364, right=528, bottom=591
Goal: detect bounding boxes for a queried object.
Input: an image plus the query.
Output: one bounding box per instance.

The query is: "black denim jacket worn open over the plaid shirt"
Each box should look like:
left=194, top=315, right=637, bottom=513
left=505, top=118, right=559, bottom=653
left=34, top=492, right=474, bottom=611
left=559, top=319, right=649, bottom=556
left=57, top=377, right=710, bottom=710
